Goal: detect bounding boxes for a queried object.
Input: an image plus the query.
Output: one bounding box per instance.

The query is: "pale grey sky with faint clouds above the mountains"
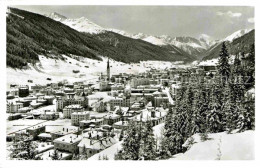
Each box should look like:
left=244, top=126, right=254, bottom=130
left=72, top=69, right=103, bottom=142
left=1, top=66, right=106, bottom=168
left=10, top=5, right=254, bottom=39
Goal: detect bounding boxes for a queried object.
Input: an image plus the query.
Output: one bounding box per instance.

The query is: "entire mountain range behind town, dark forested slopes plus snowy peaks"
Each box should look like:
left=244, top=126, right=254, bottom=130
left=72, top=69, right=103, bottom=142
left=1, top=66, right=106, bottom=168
left=6, top=8, right=254, bottom=68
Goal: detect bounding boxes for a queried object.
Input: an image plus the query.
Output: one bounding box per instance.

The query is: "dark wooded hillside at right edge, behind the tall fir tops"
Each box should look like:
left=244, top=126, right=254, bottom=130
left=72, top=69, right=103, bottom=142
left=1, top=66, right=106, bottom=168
left=202, top=30, right=255, bottom=60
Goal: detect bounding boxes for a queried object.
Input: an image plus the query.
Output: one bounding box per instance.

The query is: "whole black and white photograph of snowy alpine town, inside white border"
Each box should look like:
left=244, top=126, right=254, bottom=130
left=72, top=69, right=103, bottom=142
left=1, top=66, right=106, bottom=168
left=0, top=0, right=257, bottom=166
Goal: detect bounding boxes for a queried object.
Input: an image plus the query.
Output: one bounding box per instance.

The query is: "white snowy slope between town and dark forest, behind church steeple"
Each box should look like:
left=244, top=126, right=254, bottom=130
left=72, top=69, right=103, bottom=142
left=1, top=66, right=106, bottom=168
left=7, top=55, right=172, bottom=89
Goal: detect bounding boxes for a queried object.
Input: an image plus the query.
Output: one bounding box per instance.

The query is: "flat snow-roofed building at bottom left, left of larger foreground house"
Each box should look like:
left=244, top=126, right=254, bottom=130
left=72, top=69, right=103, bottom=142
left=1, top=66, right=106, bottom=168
left=53, top=134, right=82, bottom=154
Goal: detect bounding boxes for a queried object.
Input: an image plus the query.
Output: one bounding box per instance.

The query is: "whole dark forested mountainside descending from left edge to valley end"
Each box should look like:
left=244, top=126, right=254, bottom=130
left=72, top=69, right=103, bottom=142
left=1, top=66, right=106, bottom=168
left=6, top=8, right=193, bottom=68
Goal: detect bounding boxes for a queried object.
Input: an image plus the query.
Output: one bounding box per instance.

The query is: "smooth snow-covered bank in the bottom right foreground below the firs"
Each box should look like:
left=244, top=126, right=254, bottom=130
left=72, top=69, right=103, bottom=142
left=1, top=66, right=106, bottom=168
left=170, top=130, right=255, bottom=160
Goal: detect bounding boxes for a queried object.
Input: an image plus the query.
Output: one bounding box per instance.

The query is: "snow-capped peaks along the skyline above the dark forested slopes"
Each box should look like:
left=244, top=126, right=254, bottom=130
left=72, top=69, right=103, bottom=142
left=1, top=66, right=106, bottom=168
left=45, top=12, right=252, bottom=58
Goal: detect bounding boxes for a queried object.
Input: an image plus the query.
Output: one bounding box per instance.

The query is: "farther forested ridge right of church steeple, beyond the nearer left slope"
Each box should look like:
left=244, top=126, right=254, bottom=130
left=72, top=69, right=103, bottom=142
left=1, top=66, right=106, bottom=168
left=92, top=31, right=194, bottom=62
